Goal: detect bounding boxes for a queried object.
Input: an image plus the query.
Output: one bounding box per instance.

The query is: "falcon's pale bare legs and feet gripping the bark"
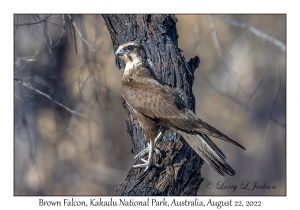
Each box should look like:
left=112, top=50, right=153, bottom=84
left=133, top=132, right=162, bottom=171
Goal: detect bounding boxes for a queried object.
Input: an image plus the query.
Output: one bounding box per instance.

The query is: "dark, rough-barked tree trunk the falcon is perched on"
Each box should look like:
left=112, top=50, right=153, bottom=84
left=103, top=15, right=203, bottom=196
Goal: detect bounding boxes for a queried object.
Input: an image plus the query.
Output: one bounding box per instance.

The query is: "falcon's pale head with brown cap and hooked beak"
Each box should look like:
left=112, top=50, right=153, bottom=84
left=116, top=41, right=143, bottom=66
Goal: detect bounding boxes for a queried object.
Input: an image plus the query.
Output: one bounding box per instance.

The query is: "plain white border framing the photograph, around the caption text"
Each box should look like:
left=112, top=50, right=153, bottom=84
left=0, top=0, right=300, bottom=209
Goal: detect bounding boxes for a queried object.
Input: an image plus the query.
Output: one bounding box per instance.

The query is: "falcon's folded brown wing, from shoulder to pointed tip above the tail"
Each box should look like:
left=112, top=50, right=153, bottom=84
left=121, top=78, right=245, bottom=149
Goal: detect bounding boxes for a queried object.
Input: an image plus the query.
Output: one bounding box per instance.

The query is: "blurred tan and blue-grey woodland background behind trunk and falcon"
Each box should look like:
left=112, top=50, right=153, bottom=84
left=14, top=15, right=286, bottom=195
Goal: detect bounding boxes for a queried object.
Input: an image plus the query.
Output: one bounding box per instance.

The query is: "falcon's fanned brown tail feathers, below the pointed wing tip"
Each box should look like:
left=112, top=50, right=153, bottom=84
left=177, top=130, right=235, bottom=176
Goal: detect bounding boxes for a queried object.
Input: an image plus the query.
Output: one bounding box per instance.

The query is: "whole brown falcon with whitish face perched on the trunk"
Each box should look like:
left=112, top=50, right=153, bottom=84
left=116, top=42, right=245, bottom=176
